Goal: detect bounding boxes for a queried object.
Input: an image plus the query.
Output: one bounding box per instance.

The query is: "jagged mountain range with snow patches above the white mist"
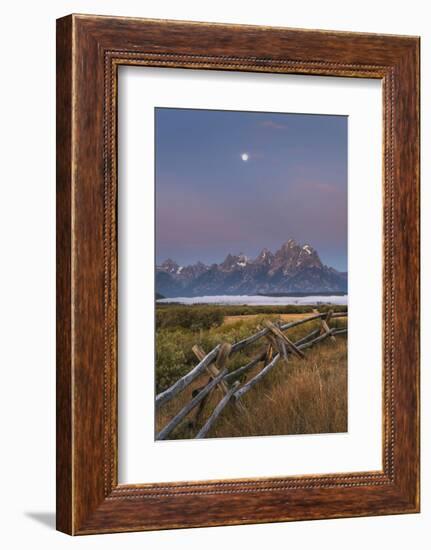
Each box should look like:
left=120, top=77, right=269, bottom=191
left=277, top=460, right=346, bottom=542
left=156, top=239, right=347, bottom=297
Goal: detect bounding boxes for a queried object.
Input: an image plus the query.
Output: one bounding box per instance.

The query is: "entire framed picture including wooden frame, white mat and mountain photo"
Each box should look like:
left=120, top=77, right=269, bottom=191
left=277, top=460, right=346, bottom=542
left=57, top=15, right=419, bottom=535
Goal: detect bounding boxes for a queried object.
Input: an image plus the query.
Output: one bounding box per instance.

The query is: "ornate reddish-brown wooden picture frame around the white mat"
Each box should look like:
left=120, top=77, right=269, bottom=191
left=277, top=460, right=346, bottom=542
left=57, top=15, right=419, bottom=534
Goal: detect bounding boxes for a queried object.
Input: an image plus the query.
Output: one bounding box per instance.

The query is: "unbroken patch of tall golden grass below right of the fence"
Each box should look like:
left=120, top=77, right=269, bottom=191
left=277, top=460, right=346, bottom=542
left=209, top=337, right=347, bottom=437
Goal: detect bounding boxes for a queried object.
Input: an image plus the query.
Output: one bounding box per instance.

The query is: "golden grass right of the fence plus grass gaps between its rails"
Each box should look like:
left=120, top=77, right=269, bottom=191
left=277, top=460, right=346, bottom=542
left=156, top=315, right=347, bottom=439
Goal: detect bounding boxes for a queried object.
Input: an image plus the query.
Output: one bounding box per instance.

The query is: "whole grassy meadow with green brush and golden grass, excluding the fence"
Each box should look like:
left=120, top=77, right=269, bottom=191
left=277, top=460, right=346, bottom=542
left=156, top=305, right=347, bottom=439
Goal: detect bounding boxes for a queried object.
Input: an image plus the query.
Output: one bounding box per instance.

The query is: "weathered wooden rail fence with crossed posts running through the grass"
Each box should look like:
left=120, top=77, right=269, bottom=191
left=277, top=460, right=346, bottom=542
left=156, top=310, right=348, bottom=440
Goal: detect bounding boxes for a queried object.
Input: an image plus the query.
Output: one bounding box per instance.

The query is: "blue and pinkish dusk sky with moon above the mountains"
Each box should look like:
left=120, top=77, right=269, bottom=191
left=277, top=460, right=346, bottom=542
left=155, top=108, right=348, bottom=271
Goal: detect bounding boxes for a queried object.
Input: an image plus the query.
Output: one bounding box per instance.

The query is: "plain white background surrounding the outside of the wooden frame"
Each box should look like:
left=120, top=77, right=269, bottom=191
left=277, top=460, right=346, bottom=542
left=0, top=0, right=431, bottom=550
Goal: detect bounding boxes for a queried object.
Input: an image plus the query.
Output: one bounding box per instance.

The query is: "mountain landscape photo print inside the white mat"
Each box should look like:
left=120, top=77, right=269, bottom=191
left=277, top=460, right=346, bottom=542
left=154, top=107, right=348, bottom=440
